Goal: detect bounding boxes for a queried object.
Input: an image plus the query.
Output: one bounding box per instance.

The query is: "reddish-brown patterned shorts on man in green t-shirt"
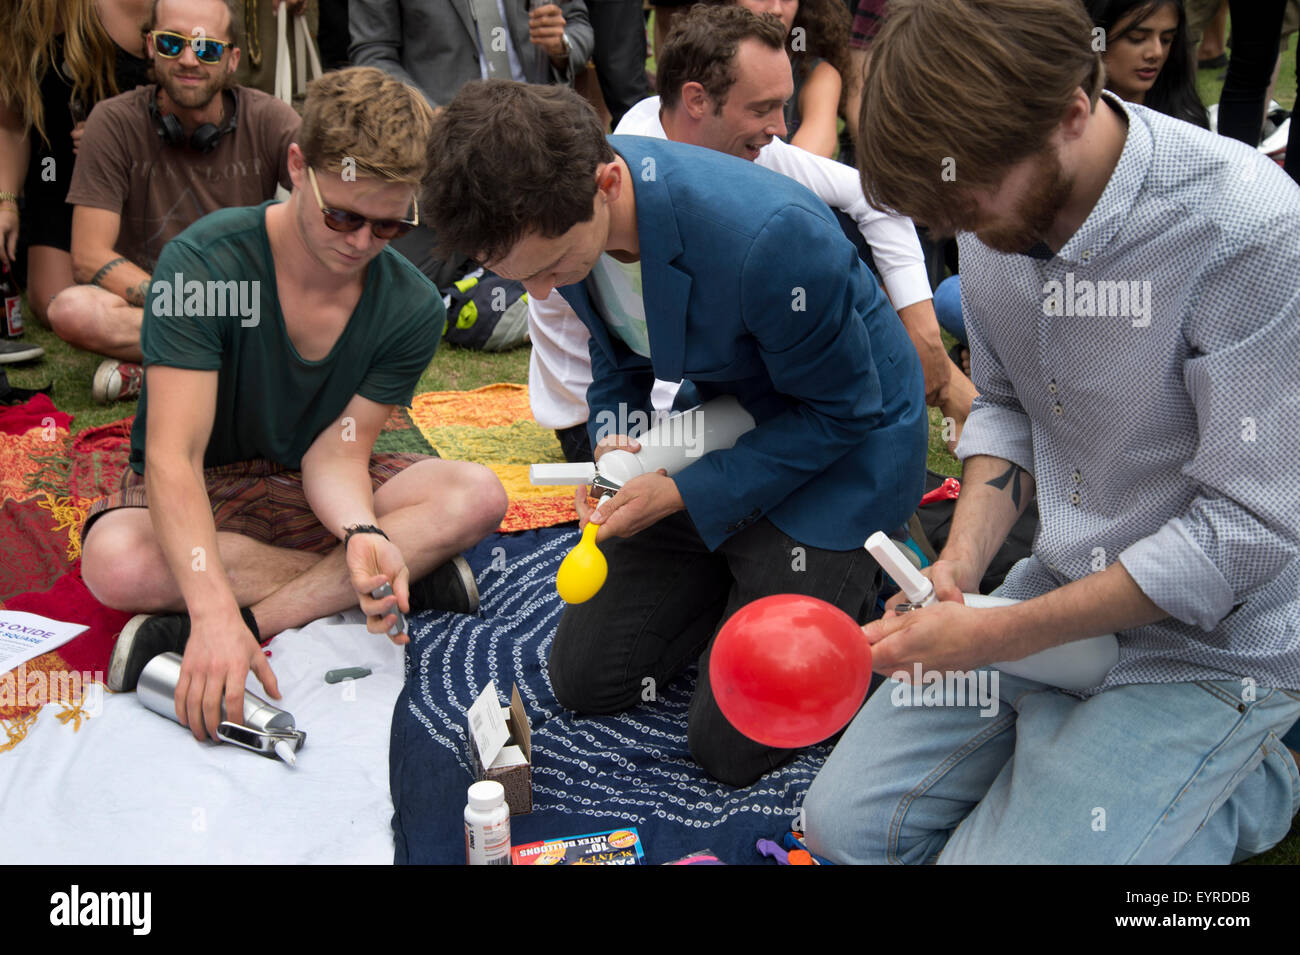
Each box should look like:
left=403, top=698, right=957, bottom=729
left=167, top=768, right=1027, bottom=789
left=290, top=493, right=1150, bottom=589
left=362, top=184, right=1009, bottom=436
left=82, top=453, right=429, bottom=554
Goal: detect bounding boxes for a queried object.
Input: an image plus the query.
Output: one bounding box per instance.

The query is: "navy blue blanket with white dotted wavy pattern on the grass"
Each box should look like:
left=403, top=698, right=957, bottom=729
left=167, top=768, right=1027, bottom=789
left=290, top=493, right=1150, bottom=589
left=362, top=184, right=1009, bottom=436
left=389, top=528, right=829, bottom=864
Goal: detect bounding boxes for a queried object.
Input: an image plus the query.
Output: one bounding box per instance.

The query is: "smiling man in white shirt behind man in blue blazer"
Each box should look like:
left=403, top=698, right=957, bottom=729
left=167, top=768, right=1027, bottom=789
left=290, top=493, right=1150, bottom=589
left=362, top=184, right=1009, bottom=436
left=529, top=6, right=975, bottom=460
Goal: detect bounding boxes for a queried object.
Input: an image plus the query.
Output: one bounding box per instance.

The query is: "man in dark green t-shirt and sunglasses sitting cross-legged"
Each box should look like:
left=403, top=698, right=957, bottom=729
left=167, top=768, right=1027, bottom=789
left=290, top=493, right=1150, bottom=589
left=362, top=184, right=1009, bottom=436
left=82, top=69, right=506, bottom=739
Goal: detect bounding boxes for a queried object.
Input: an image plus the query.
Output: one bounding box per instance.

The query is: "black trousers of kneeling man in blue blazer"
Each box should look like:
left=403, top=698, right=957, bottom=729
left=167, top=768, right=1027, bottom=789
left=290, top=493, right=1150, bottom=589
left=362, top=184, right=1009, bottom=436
left=550, top=513, right=880, bottom=786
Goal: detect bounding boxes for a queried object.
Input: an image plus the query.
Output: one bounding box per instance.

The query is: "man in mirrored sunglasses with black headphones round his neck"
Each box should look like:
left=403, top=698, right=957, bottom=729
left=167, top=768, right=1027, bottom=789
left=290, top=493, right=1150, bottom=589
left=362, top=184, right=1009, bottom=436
left=49, top=0, right=300, bottom=401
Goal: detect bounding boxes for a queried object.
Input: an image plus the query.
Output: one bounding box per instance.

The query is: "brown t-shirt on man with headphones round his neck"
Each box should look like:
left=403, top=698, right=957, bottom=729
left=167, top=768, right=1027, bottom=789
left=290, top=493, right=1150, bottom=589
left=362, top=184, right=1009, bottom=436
left=68, top=86, right=302, bottom=272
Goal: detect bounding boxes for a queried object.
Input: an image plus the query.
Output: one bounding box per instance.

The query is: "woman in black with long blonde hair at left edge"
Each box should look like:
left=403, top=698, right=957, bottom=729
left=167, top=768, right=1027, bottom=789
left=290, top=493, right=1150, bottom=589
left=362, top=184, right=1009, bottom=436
left=0, top=0, right=150, bottom=328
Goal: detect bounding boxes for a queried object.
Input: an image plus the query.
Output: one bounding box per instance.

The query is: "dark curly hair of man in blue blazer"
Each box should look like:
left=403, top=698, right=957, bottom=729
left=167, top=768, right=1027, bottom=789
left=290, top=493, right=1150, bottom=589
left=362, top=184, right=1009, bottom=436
left=426, top=79, right=614, bottom=261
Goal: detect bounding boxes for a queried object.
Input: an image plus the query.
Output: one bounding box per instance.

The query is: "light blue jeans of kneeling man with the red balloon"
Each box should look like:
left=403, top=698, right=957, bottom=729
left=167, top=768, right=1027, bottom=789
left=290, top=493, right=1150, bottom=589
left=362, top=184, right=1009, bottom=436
left=805, top=673, right=1300, bottom=864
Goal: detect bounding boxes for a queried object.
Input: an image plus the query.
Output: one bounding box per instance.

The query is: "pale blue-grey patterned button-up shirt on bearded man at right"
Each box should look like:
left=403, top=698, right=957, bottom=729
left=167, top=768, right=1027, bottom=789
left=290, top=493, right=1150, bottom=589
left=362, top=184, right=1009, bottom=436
left=958, top=95, right=1300, bottom=690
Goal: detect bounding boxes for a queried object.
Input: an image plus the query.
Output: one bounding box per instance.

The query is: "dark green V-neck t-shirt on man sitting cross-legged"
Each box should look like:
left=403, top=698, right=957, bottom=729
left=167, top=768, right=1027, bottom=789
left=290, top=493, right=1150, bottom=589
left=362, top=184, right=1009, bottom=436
left=131, top=203, right=447, bottom=474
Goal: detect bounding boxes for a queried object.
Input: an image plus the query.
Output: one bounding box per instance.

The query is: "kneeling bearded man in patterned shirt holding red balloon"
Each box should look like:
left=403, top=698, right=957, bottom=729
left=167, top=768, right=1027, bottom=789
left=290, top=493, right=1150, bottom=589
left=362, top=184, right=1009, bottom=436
left=805, top=0, right=1300, bottom=863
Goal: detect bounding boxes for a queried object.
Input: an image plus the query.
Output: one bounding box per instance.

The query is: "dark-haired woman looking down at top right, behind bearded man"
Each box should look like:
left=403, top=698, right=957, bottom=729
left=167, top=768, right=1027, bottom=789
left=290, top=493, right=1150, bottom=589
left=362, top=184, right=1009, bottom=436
left=1084, top=0, right=1209, bottom=129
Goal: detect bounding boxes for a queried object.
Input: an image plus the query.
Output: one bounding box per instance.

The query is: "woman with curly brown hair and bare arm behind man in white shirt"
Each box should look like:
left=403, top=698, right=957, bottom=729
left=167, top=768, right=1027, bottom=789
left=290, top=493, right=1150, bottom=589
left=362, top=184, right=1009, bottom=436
left=711, top=0, right=850, bottom=159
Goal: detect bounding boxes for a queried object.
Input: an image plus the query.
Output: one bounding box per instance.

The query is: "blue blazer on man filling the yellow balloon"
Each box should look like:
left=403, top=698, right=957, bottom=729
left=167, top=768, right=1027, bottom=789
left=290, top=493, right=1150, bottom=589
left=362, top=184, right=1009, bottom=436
left=560, top=136, right=928, bottom=551
